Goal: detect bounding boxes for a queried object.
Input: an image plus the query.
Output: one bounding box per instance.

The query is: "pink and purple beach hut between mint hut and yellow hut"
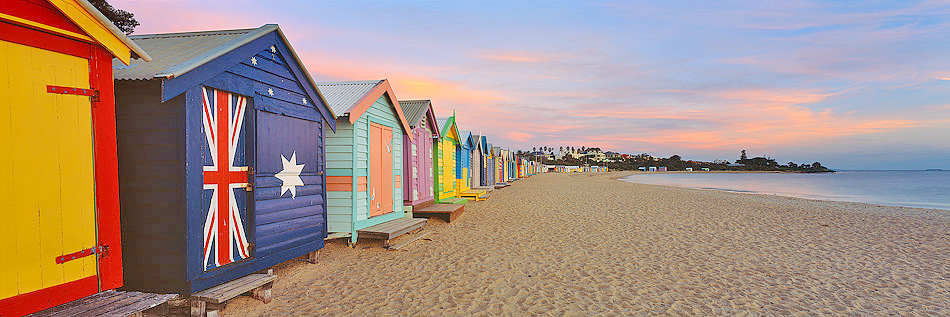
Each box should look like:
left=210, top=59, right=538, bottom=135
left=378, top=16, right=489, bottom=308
left=399, top=100, right=441, bottom=209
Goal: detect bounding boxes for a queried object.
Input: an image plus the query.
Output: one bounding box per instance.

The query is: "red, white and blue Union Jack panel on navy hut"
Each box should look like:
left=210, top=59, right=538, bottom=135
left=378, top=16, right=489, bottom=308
left=201, top=87, right=250, bottom=270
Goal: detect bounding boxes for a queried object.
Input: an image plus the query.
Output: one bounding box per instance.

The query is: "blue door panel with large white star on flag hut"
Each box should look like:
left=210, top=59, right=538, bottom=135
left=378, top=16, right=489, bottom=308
left=254, top=111, right=326, bottom=256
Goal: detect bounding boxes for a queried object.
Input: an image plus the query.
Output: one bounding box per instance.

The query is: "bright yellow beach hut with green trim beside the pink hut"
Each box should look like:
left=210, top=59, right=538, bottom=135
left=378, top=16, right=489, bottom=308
left=433, top=116, right=468, bottom=204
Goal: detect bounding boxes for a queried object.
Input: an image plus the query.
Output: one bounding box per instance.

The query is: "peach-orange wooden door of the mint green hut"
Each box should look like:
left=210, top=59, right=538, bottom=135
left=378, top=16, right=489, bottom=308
left=369, top=123, right=395, bottom=217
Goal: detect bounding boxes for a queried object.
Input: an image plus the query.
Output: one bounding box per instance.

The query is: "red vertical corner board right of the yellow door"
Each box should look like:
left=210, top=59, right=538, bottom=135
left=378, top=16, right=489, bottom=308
left=89, top=46, right=122, bottom=290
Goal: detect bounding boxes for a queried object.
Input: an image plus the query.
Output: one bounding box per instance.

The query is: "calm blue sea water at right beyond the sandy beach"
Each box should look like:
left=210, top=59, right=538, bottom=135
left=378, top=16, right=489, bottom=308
left=621, top=171, right=950, bottom=210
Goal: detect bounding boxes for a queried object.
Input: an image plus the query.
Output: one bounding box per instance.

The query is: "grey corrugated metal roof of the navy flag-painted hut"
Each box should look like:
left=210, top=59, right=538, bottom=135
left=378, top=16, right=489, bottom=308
left=112, top=24, right=264, bottom=80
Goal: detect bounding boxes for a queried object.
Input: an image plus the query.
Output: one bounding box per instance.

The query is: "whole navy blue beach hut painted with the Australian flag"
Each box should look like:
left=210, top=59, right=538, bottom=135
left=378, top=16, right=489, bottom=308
left=113, top=24, right=336, bottom=294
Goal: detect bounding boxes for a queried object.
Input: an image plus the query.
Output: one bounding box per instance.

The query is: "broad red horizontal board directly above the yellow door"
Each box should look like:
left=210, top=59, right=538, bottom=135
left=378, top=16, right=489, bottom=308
left=0, top=21, right=88, bottom=58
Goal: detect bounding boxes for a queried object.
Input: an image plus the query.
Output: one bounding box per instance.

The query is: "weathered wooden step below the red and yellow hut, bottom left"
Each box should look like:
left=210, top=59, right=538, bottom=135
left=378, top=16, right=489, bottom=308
left=29, top=290, right=178, bottom=316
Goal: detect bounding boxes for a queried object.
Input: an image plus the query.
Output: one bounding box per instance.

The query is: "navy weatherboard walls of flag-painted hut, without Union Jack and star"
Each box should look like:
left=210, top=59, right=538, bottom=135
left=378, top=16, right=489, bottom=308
left=116, top=32, right=326, bottom=294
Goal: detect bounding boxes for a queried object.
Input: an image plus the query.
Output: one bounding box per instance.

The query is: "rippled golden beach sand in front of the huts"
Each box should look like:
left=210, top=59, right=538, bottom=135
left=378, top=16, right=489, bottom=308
left=222, top=172, right=950, bottom=316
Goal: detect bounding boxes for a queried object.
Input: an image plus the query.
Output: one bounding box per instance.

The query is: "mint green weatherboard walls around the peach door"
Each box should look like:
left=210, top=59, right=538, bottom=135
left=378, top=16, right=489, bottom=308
left=327, top=95, right=405, bottom=242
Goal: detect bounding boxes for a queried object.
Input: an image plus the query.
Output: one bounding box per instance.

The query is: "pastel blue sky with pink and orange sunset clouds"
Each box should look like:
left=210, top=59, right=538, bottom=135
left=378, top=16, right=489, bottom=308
left=117, top=0, right=950, bottom=169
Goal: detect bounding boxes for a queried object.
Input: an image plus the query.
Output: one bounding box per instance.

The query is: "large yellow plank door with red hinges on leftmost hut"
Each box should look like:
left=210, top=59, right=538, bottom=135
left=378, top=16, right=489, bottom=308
left=0, top=41, right=96, bottom=299
